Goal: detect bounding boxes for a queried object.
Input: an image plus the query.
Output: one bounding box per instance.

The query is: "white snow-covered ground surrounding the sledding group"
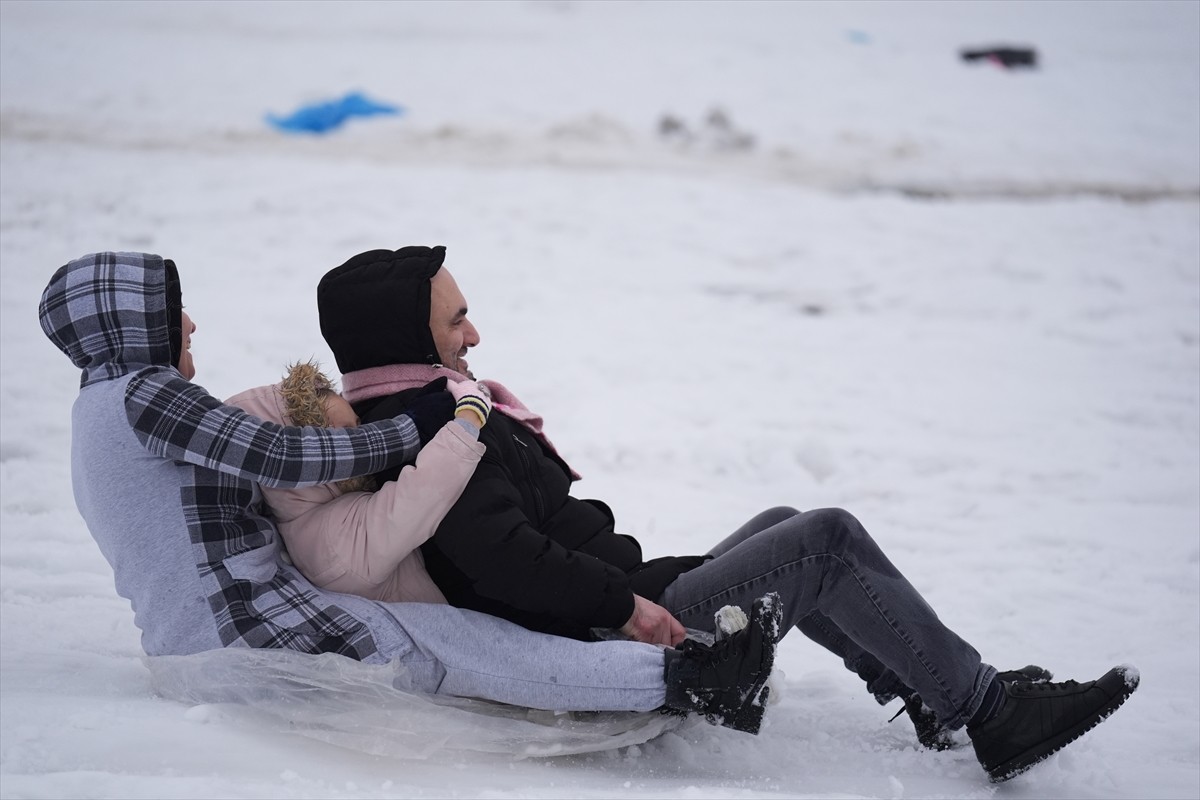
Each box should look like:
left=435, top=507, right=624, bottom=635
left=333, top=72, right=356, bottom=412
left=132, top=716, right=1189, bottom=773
left=0, top=0, right=1200, bottom=799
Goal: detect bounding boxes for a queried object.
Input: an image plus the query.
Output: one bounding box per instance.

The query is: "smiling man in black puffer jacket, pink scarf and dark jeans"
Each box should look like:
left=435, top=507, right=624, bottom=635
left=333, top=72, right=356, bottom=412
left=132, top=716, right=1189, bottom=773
left=317, top=247, right=1138, bottom=781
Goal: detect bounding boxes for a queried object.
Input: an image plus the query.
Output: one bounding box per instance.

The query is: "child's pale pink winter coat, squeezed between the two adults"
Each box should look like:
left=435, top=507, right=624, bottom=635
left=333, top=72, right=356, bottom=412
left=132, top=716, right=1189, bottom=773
left=228, top=384, right=486, bottom=603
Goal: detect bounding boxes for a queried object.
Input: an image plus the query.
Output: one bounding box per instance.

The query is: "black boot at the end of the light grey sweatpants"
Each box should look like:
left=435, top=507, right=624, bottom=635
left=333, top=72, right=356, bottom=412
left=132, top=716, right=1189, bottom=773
left=665, top=593, right=784, bottom=733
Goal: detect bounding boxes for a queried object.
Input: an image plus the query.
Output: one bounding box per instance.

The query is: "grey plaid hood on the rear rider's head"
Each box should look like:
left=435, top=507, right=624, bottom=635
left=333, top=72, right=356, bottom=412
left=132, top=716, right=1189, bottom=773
left=37, top=253, right=174, bottom=386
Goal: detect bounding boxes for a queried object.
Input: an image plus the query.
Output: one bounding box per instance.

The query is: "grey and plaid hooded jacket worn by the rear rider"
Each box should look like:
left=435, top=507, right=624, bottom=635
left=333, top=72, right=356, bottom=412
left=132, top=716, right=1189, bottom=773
left=38, top=253, right=420, bottom=661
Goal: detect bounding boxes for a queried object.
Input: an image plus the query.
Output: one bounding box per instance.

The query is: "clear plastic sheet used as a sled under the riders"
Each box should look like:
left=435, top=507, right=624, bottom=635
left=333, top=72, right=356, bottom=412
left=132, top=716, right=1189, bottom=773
left=143, top=648, right=684, bottom=759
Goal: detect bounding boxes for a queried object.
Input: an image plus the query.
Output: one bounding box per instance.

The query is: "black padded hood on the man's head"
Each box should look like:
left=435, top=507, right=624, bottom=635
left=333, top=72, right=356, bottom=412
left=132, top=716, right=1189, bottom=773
left=317, top=246, right=446, bottom=374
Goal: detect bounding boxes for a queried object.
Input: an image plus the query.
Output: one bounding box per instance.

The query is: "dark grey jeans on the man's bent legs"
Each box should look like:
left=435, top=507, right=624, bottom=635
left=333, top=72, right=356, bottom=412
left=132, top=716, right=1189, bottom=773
left=658, top=507, right=996, bottom=729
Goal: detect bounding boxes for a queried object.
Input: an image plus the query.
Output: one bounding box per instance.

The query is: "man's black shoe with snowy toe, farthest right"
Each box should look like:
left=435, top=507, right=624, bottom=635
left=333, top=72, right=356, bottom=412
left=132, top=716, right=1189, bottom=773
left=967, top=667, right=1140, bottom=783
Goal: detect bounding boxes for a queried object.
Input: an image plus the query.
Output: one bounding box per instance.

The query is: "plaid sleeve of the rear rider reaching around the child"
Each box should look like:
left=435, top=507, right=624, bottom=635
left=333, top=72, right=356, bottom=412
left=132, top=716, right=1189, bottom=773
left=125, top=368, right=420, bottom=488
